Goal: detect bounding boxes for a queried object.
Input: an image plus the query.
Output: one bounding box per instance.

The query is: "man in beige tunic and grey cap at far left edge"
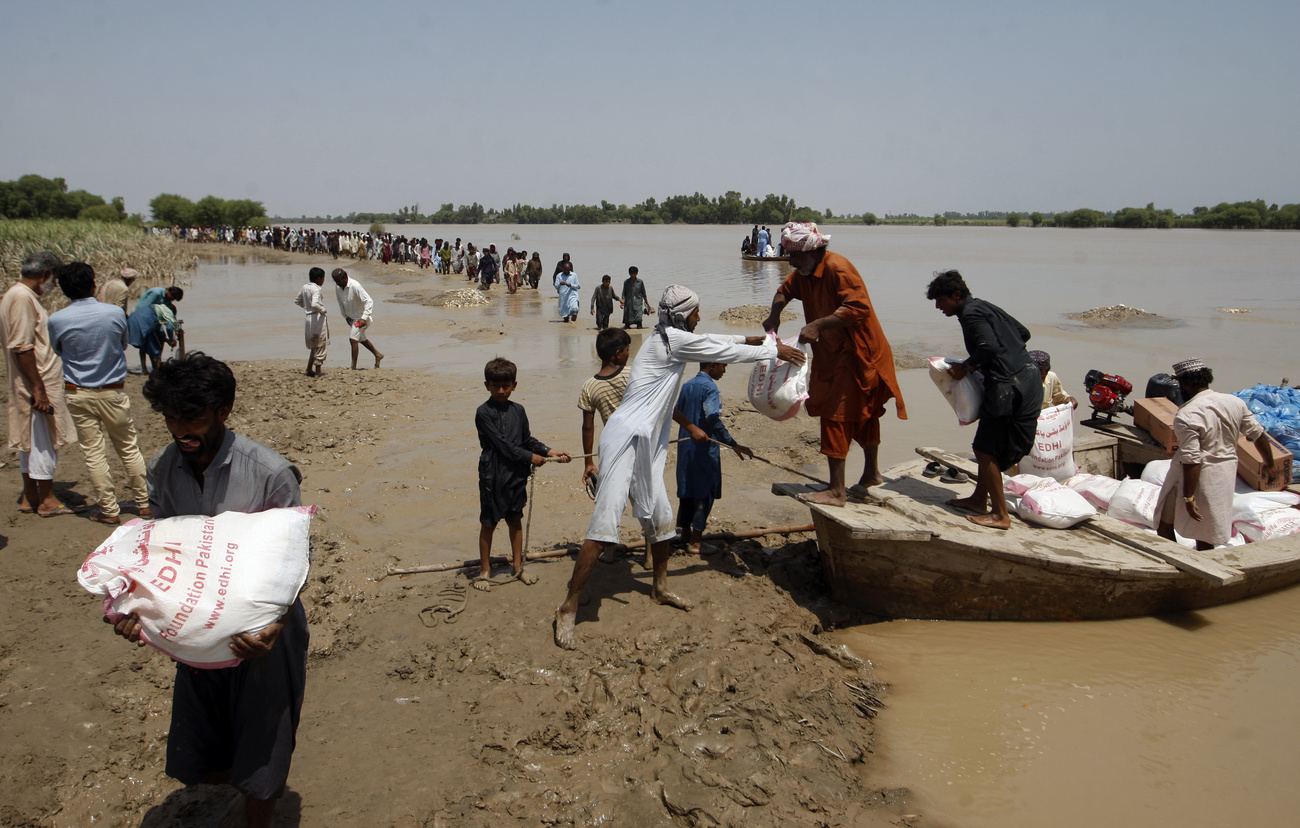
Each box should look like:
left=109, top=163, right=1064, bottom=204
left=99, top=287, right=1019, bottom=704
left=0, top=251, right=77, bottom=517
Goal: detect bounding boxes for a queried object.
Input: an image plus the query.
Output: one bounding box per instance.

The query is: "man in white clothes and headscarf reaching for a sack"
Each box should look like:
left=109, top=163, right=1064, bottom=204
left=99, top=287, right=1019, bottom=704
left=555, top=285, right=805, bottom=650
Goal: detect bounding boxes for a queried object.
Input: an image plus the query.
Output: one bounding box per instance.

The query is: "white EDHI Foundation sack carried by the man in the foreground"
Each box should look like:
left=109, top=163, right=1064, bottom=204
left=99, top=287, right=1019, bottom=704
left=77, top=506, right=316, bottom=669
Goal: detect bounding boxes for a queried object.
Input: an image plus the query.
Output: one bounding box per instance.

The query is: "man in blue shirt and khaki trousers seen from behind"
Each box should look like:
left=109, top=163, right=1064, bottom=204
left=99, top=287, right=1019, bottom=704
left=49, top=261, right=152, bottom=526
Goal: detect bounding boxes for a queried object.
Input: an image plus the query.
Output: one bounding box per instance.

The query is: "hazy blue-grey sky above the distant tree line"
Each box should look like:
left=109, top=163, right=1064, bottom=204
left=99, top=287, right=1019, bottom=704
left=0, top=0, right=1300, bottom=218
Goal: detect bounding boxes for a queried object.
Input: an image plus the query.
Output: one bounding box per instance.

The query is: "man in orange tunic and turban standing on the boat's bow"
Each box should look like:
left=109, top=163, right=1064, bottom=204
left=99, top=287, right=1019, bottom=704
left=763, top=221, right=907, bottom=506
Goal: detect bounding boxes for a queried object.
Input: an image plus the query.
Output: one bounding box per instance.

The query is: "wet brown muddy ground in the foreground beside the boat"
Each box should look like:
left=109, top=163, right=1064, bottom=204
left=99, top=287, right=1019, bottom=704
left=0, top=360, right=924, bottom=827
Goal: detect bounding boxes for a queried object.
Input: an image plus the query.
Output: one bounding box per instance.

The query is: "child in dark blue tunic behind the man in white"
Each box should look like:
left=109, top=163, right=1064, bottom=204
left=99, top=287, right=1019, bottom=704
left=675, top=363, right=754, bottom=555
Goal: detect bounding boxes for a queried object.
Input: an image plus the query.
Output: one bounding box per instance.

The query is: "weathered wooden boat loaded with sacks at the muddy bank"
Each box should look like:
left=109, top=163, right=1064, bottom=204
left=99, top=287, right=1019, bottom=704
left=772, top=448, right=1300, bottom=621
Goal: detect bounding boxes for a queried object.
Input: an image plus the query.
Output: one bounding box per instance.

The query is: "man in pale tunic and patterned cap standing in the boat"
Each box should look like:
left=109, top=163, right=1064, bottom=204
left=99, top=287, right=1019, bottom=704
left=1156, top=359, right=1274, bottom=550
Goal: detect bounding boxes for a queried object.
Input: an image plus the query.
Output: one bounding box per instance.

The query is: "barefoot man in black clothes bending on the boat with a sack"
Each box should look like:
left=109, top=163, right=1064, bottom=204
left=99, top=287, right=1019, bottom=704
left=926, top=270, right=1043, bottom=529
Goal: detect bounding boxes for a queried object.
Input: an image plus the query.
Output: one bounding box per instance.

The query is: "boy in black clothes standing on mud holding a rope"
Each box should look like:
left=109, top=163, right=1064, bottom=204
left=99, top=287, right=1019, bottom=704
left=473, top=356, right=572, bottom=591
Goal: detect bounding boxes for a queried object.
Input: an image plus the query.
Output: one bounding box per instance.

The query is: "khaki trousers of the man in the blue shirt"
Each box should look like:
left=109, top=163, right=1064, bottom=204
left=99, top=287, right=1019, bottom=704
left=68, top=389, right=150, bottom=517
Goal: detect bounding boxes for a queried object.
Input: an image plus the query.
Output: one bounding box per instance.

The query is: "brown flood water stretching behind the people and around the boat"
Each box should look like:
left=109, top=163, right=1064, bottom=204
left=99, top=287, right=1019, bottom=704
left=181, top=226, right=1300, bottom=828
